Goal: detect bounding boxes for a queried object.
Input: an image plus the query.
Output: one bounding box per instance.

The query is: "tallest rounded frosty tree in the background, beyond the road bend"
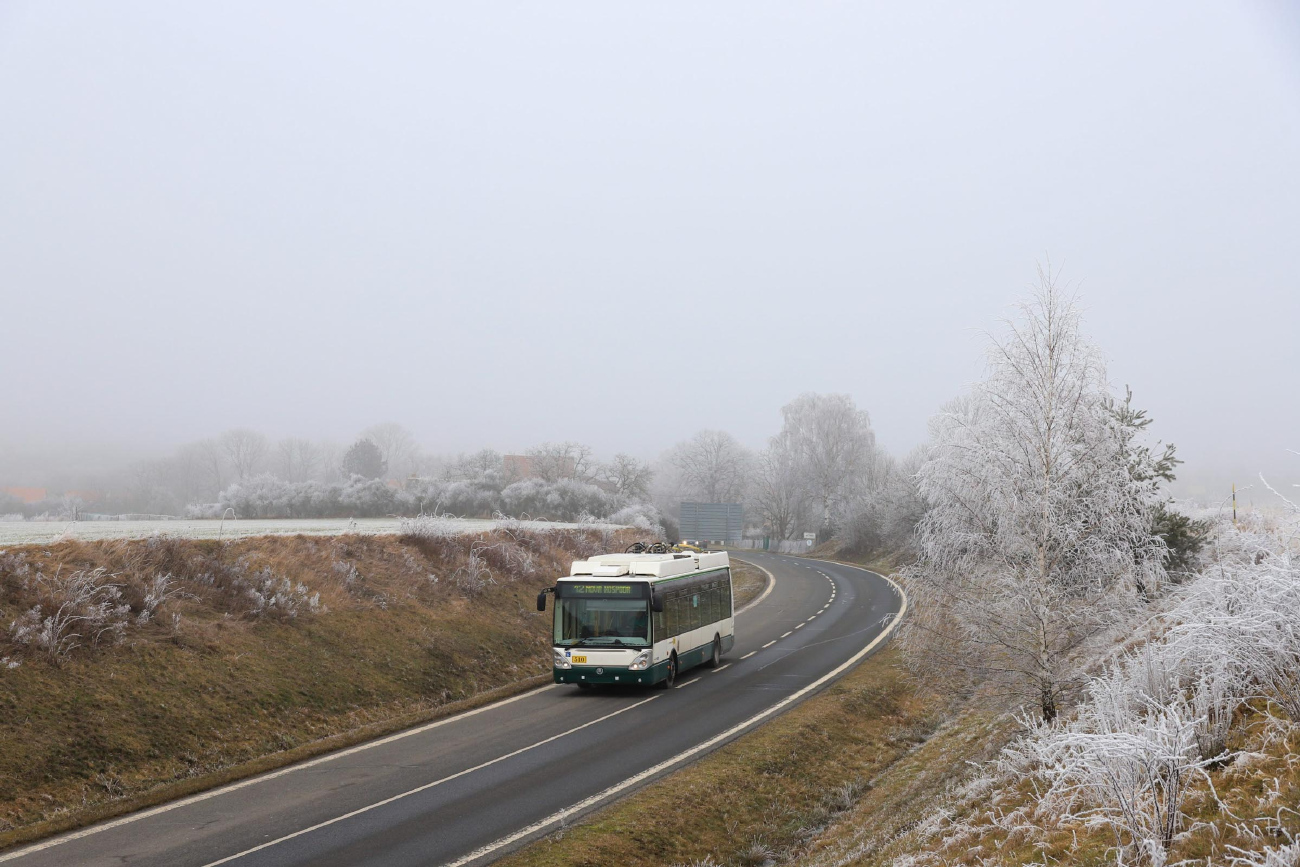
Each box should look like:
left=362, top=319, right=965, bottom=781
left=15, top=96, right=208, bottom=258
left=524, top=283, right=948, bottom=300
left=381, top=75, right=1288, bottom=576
left=781, top=394, right=876, bottom=526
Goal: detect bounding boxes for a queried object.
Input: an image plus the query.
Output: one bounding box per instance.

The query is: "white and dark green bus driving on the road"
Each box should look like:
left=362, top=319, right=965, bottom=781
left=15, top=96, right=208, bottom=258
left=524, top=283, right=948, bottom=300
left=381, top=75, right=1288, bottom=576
left=537, top=552, right=736, bottom=686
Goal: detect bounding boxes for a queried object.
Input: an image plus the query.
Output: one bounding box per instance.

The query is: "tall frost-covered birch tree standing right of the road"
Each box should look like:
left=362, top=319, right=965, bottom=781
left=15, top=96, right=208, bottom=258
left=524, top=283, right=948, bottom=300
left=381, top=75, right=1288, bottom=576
left=909, top=269, right=1162, bottom=720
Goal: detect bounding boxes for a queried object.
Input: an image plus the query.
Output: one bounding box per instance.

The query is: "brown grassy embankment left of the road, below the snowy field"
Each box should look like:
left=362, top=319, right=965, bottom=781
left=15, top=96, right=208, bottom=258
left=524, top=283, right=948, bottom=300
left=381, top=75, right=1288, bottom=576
left=0, top=530, right=650, bottom=846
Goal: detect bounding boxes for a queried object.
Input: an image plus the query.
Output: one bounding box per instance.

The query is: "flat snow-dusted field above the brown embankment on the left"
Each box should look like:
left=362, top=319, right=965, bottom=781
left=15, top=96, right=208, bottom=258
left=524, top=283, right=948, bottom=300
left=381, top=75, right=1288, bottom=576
left=0, top=517, right=600, bottom=546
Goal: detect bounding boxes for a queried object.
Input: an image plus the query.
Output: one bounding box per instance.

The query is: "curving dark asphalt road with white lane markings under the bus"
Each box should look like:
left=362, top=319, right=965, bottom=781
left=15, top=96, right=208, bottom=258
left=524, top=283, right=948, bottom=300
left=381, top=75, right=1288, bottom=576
left=0, top=551, right=902, bottom=867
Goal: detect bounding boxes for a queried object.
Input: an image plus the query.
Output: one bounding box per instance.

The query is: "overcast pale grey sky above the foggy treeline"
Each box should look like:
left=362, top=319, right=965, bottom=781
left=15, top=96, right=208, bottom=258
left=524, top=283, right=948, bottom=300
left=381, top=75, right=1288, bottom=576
left=0, top=0, right=1300, bottom=499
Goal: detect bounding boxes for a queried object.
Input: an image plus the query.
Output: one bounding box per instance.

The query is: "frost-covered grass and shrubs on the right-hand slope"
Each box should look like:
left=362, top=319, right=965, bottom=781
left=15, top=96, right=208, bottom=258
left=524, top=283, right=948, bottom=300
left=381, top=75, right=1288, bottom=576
left=796, top=516, right=1300, bottom=867
